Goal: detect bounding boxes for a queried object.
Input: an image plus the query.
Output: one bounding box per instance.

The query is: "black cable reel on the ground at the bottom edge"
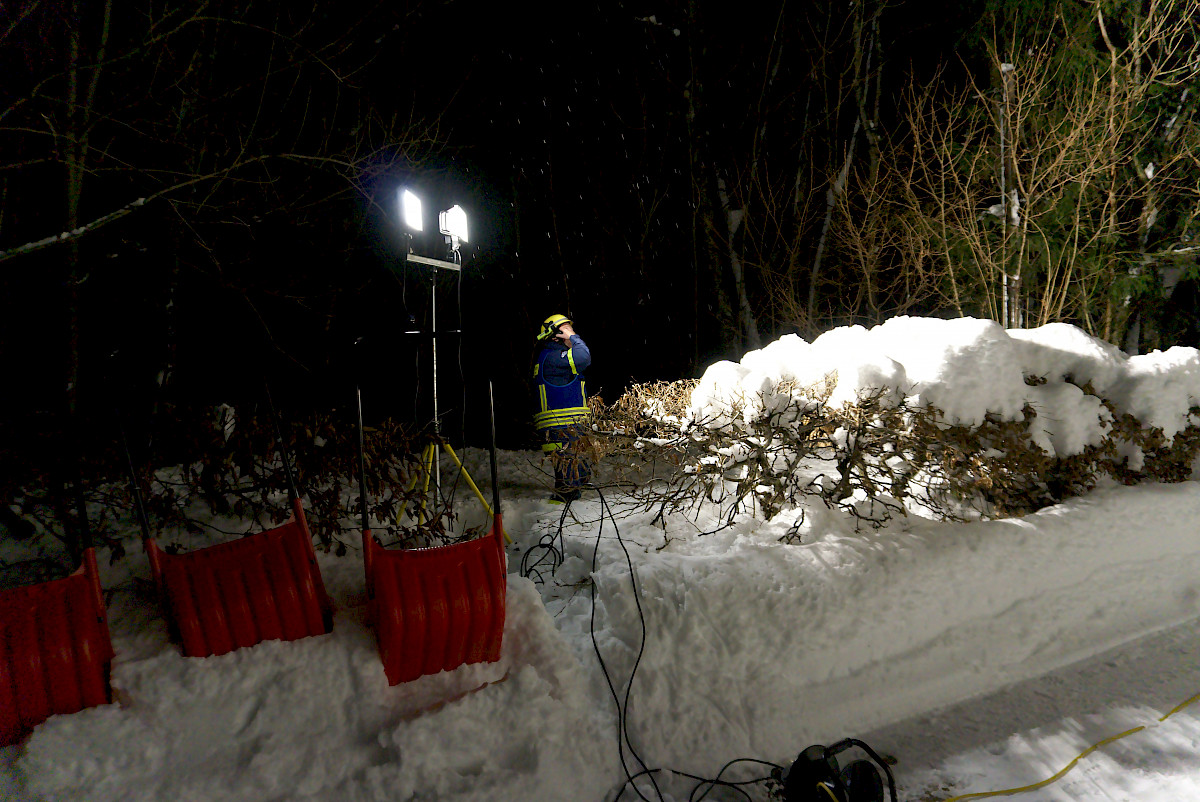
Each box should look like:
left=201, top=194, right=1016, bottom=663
left=782, top=738, right=896, bottom=802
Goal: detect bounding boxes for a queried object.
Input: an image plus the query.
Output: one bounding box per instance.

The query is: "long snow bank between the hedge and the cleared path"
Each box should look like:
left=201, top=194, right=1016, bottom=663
left=542, top=475, right=1200, bottom=798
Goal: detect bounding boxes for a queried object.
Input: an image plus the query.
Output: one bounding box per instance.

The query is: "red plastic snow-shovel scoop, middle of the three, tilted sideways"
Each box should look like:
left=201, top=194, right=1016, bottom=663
left=146, top=501, right=332, bottom=657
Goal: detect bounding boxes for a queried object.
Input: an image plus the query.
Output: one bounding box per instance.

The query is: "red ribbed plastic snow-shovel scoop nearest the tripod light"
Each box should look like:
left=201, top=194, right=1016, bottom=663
left=362, top=515, right=508, bottom=686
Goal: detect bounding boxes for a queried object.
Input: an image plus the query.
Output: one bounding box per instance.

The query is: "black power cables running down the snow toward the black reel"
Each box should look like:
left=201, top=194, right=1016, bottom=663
left=580, top=485, right=784, bottom=802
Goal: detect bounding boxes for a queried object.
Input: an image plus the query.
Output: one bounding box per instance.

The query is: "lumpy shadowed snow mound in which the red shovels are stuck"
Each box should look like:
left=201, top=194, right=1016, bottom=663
left=16, top=564, right=619, bottom=802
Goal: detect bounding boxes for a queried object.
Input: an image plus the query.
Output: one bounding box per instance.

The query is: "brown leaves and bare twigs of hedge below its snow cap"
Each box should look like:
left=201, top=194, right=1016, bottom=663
left=595, top=379, right=1200, bottom=526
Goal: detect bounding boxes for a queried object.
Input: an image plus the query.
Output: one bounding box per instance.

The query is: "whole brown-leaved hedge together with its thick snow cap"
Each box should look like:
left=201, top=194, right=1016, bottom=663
left=597, top=317, right=1200, bottom=521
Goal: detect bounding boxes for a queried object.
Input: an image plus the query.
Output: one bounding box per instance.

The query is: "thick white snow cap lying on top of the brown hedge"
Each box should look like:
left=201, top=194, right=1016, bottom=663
left=689, top=317, right=1200, bottom=456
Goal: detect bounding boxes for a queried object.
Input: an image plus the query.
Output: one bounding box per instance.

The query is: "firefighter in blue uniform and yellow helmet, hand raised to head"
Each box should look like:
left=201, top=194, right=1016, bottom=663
left=533, top=315, right=592, bottom=503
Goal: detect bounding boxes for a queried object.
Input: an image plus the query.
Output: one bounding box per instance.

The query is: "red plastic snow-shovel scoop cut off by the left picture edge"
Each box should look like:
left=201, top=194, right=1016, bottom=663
left=0, top=549, right=113, bottom=746
